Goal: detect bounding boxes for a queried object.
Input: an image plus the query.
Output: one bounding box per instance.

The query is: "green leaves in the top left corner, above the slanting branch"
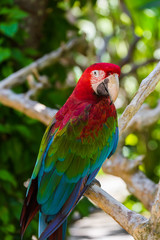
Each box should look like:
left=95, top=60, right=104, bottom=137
left=0, top=1, right=32, bottom=79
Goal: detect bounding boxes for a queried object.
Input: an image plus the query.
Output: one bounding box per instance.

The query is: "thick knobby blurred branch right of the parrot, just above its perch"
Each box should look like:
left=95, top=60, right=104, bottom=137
left=103, top=153, right=157, bottom=210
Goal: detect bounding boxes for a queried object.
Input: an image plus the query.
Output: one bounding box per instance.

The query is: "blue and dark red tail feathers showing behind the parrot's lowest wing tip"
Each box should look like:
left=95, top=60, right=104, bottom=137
left=38, top=212, right=67, bottom=240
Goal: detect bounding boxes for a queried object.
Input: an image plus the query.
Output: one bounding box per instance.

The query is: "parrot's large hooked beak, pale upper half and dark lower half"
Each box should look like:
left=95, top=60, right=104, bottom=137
left=96, top=73, right=119, bottom=102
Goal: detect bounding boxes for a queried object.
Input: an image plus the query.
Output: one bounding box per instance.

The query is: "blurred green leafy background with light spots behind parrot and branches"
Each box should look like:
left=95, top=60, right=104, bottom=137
left=0, top=0, right=160, bottom=240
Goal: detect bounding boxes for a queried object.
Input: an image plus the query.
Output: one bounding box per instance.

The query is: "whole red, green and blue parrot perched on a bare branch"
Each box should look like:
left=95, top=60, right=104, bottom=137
left=20, top=62, right=121, bottom=240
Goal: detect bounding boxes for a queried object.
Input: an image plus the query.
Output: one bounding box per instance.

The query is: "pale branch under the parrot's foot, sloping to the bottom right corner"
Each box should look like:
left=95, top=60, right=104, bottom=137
left=84, top=183, right=160, bottom=240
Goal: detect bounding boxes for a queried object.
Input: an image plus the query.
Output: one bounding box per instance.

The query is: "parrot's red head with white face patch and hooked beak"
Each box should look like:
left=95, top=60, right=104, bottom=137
left=75, top=63, right=120, bottom=102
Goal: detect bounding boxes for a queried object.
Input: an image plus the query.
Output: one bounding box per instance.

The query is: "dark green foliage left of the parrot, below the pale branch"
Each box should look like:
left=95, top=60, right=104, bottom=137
left=0, top=106, right=45, bottom=239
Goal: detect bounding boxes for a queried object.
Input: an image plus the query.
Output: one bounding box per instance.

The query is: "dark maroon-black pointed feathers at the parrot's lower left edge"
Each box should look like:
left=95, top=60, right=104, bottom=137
left=20, top=178, right=40, bottom=239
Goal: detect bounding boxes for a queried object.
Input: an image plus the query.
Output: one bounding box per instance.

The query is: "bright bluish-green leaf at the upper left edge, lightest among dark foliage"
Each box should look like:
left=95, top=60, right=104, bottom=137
left=0, top=22, right=18, bottom=37
